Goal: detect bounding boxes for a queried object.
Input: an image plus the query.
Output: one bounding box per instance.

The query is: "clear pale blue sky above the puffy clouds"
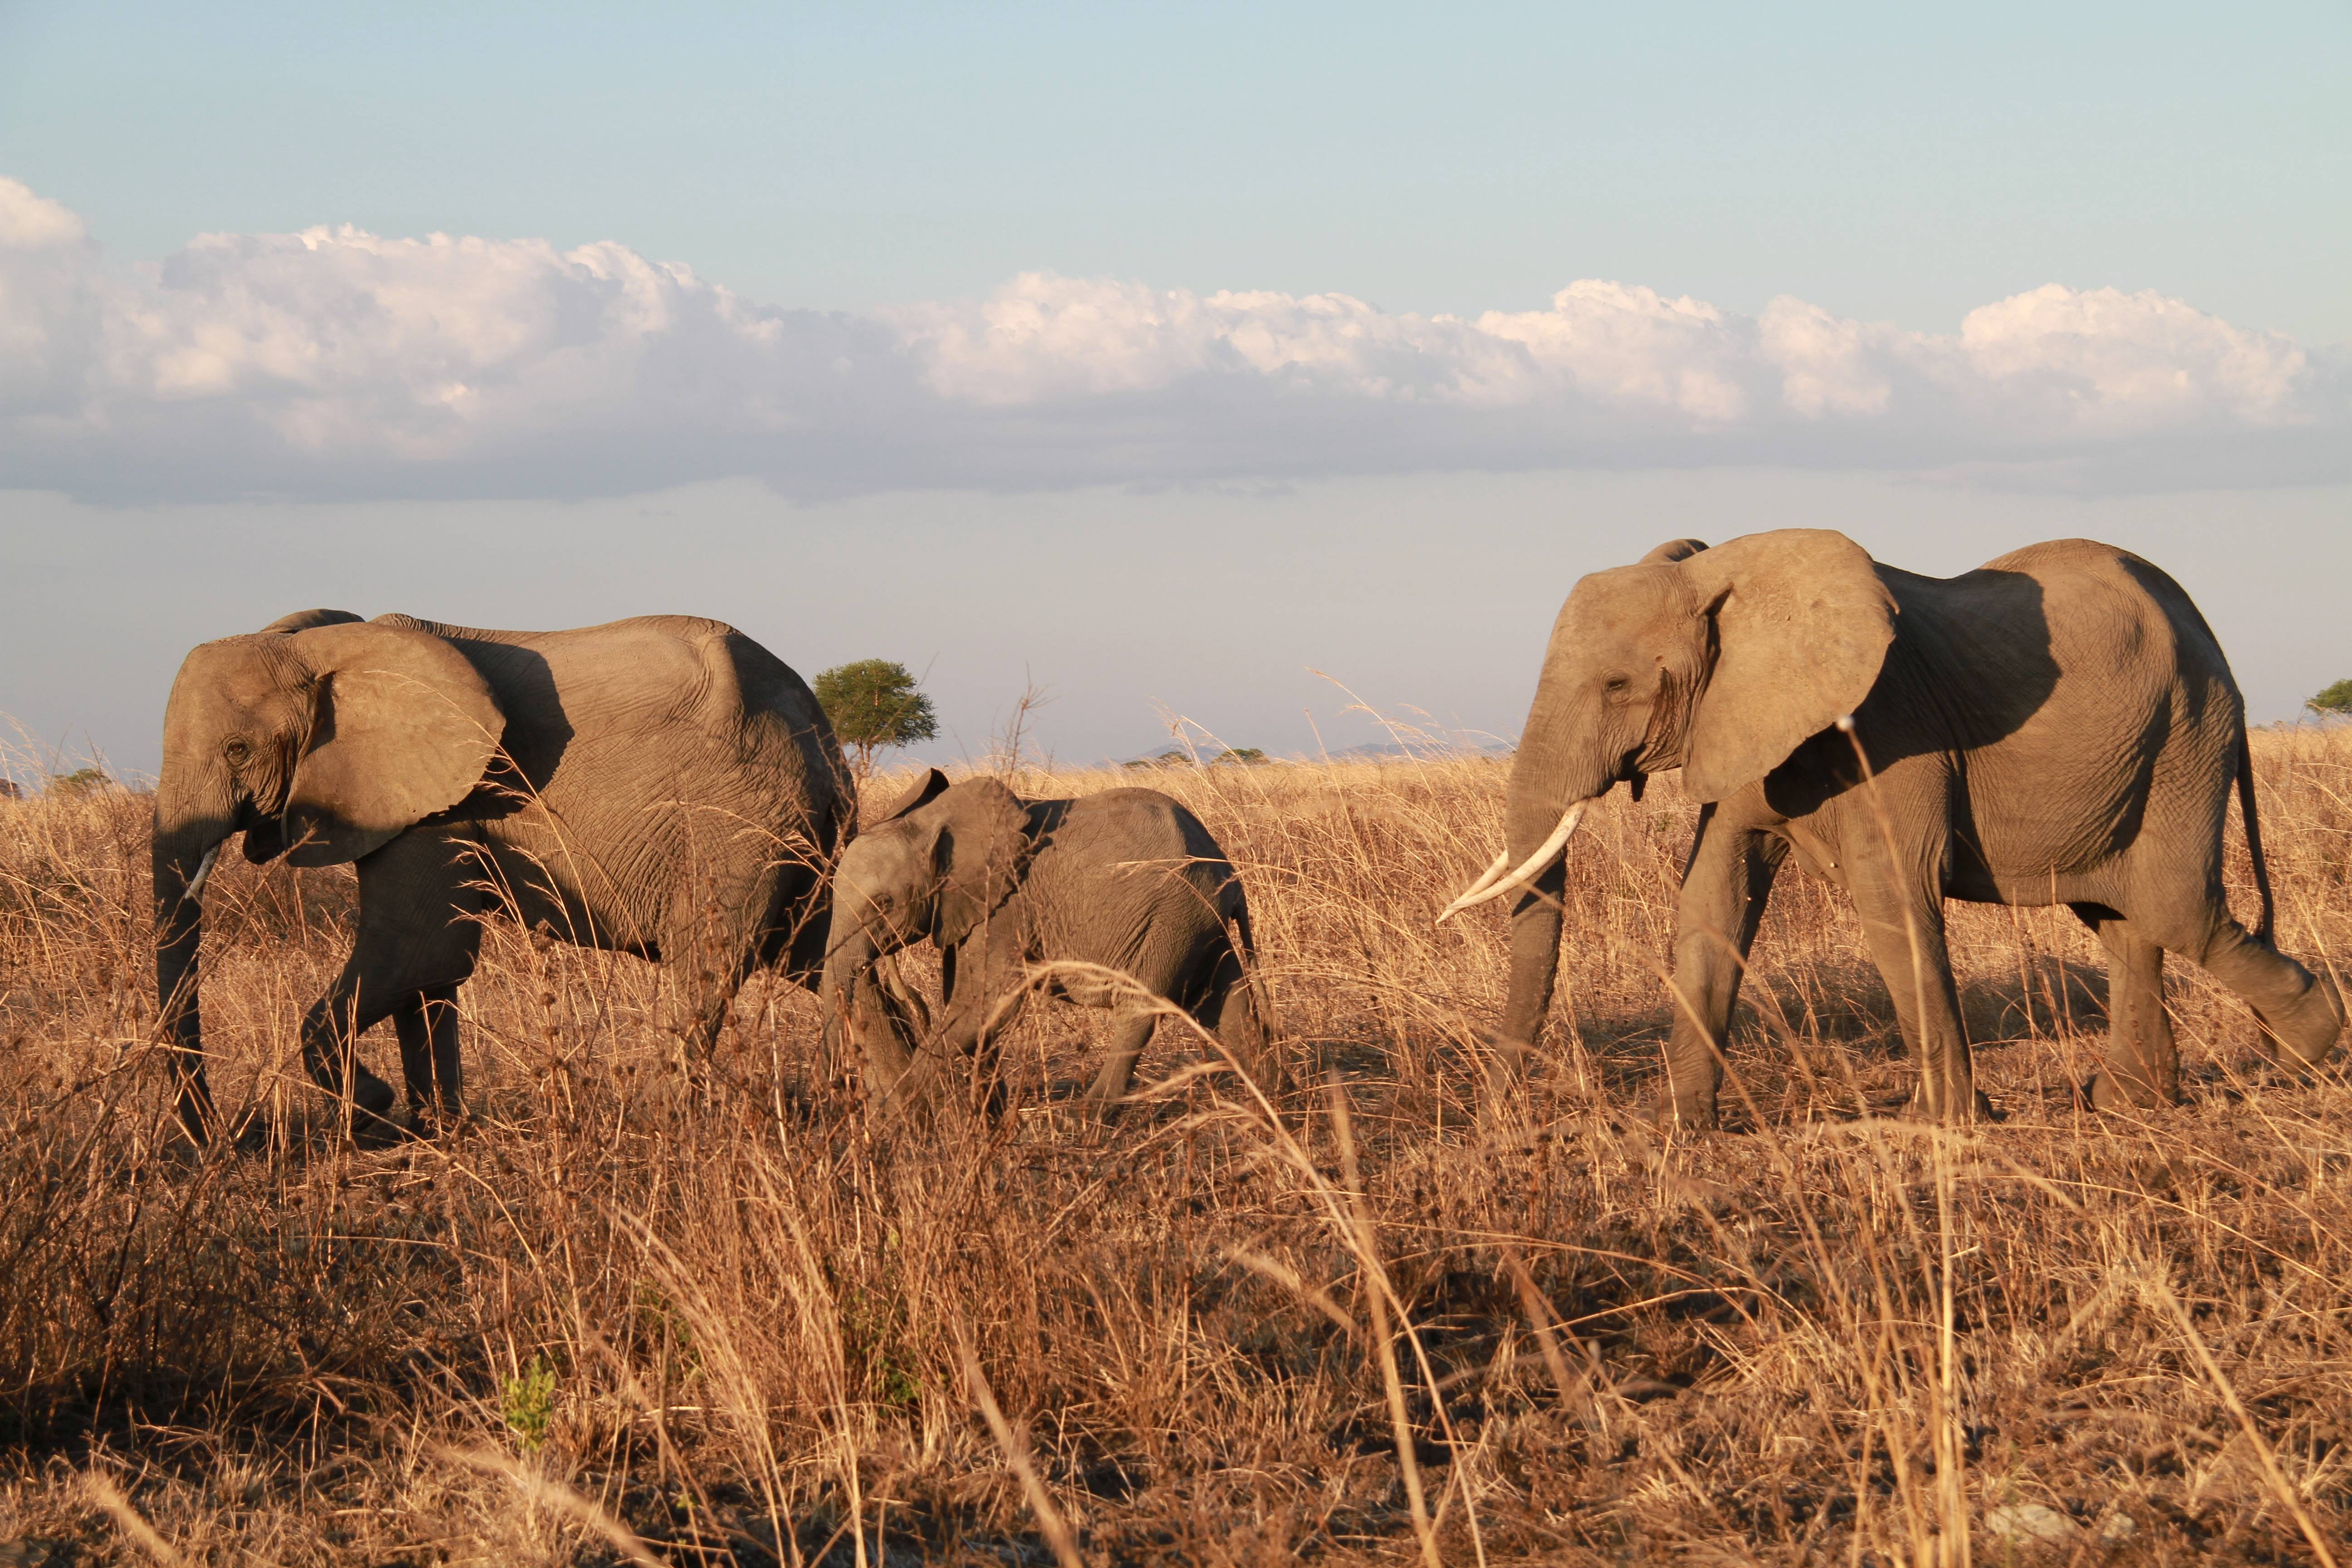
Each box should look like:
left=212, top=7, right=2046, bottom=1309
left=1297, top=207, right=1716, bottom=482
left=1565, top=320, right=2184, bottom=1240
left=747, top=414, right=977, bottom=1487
left=0, top=0, right=2352, bottom=341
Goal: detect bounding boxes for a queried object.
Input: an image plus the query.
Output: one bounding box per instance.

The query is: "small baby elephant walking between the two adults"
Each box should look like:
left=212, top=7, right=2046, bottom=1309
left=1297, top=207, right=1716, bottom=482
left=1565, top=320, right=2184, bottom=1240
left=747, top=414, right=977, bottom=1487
left=823, top=769, right=1268, bottom=1119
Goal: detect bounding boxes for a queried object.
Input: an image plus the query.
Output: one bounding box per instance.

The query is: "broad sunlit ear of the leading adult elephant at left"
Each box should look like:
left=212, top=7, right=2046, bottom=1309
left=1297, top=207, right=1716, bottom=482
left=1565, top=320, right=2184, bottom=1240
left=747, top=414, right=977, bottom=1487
left=280, top=621, right=506, bottom=865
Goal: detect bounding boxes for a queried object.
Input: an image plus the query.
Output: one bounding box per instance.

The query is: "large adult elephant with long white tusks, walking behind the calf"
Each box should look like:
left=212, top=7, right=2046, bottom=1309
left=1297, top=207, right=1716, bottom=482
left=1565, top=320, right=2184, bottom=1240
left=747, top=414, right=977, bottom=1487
left=1440, top=529, right=2342, bottom=1126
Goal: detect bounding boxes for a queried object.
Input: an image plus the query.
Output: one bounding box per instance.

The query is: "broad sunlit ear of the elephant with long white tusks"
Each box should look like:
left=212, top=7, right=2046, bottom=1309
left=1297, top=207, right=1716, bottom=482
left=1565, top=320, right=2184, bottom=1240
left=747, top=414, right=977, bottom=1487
left=1677, top=529, right=1896, bottom=802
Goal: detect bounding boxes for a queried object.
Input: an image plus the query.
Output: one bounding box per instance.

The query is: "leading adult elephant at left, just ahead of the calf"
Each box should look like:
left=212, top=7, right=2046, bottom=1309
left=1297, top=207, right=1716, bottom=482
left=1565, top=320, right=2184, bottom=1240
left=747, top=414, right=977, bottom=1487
left=153, top=609, right=856, bottom=1138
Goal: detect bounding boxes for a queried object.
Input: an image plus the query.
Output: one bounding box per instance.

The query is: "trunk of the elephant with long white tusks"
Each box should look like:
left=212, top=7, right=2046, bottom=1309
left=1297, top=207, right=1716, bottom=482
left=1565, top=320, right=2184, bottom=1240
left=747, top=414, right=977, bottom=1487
left=1480, top=691, right=1616, bottom=1065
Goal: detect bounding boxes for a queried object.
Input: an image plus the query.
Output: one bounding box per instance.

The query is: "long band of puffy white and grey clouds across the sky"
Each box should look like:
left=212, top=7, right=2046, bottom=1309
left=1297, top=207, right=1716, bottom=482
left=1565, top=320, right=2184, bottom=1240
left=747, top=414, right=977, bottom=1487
left=0, top=179, right=2352, bottom=501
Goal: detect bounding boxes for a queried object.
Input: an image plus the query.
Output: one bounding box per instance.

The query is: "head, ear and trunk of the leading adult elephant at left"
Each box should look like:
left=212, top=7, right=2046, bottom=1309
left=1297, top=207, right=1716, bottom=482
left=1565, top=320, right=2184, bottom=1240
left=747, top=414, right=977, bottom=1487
left=153, top=609, right=506, bottom=1136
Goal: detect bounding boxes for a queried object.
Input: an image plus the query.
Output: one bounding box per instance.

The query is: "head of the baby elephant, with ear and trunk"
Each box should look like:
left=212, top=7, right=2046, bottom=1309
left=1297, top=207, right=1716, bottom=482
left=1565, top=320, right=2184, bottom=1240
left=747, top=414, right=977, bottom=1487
left=823, top=769, right=1030, bottom=1081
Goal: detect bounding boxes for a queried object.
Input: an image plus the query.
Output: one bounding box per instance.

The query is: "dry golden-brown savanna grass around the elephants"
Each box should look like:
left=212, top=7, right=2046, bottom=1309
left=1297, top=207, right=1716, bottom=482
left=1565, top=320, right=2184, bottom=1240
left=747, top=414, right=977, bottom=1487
left=0, top=731, right=2352, bottom=1566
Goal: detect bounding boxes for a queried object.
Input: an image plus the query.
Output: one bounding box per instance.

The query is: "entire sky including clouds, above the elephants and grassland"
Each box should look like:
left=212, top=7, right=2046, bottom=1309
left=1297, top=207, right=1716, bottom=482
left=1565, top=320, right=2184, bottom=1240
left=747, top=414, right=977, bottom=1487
left=0, top=0, right=2352, bottom=766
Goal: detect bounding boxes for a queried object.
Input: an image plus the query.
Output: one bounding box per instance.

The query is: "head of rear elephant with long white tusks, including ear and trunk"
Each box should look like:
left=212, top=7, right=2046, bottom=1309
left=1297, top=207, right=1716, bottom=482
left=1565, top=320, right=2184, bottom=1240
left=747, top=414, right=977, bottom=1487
left=1440, top=529, right=1896, bottom=1062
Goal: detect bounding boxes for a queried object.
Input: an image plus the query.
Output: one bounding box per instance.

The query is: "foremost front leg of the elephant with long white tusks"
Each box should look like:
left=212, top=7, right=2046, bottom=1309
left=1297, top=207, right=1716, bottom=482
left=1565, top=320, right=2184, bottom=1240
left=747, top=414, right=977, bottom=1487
left=1661, top=806, right=1788, bottom=1128
